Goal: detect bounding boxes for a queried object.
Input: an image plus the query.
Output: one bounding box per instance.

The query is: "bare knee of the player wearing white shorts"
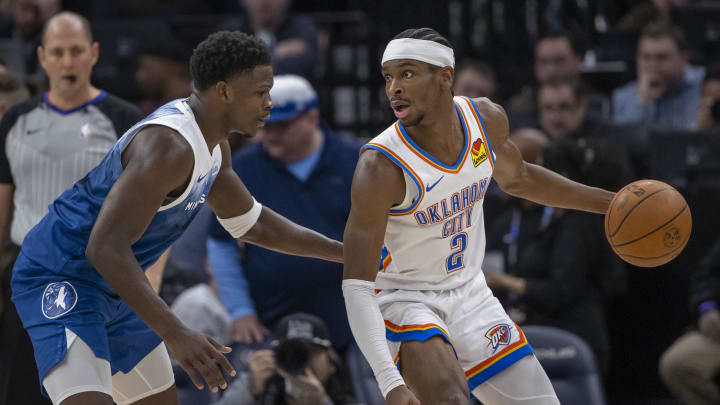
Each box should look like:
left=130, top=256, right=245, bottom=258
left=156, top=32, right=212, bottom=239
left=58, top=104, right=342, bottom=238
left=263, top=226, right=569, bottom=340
left=400, top=335, right=470, bottom=405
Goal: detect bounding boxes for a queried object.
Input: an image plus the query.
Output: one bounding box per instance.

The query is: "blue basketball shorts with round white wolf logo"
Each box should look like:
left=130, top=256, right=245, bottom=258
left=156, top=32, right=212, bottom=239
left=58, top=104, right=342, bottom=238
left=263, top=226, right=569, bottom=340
left=11, top=252, right=162, bottom=384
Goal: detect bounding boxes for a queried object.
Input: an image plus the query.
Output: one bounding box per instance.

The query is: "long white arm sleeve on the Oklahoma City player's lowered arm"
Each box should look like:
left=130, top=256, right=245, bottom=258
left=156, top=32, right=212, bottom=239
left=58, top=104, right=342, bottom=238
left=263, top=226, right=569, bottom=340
left=342, top=279, right=405, bottom=397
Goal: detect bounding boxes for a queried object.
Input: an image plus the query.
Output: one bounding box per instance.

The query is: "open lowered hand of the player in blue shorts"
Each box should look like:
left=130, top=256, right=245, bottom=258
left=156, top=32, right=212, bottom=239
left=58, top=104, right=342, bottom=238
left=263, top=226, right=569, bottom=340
left=164, top=327, right=235, bottom=392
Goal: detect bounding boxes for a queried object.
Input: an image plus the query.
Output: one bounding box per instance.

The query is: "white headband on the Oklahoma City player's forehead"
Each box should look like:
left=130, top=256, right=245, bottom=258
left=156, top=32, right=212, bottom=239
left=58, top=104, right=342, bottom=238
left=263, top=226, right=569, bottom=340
left=381, top=38, right=455, bottom=68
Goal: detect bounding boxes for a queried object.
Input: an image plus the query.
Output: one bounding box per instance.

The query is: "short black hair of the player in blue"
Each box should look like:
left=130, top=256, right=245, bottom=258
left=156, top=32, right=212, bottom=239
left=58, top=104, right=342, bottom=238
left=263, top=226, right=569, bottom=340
left=190, top=31, right=271, bottom=91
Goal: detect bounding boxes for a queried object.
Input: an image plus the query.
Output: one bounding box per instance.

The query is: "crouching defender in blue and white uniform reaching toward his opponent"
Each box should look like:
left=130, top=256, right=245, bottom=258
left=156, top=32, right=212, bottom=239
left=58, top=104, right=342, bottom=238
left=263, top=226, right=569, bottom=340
left=12, top=32, right=342, bottom=405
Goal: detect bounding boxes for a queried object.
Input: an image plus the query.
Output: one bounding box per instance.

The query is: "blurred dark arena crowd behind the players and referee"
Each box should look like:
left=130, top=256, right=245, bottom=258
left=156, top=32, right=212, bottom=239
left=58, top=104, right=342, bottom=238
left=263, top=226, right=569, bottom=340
left=0, top=0, right=720, bottom=405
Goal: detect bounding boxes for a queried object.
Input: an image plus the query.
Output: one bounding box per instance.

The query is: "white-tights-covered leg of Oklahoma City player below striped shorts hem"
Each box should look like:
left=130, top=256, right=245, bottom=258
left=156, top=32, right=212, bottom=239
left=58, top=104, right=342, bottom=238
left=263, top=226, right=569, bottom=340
left=473, top=354, right=560, bottom=405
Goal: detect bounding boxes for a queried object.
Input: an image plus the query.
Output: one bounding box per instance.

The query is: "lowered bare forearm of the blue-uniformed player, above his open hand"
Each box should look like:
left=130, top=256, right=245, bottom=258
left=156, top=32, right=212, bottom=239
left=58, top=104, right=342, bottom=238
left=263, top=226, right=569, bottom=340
left=86, top=241, right=183, bottom=339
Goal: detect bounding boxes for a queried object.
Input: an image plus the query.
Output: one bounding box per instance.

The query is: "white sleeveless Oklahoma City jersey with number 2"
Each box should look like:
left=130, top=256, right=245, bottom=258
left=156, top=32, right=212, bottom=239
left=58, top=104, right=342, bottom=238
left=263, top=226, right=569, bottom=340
left=364, top=97, right=495, bottom=290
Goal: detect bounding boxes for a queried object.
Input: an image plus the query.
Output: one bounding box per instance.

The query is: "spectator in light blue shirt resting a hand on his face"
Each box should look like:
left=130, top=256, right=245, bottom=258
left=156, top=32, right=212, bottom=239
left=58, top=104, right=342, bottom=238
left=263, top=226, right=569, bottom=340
left=612, top=23, right=704, bottom=129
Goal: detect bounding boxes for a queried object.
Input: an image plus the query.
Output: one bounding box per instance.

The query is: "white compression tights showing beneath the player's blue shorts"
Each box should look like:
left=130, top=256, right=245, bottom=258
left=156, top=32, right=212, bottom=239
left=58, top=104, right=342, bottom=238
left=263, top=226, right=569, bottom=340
left=42, top=329, right=175, bottom=405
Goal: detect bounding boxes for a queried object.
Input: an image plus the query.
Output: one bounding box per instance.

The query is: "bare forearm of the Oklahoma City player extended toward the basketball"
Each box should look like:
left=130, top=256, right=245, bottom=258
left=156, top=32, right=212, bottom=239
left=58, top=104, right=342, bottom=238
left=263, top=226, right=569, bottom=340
left=503, top=163, right=615, bottom=214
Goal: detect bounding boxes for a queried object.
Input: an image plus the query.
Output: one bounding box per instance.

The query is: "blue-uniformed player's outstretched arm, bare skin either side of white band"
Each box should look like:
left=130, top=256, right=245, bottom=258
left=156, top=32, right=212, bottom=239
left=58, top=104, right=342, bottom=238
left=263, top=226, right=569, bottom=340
left=208, top=142, right=343, bottom=262
